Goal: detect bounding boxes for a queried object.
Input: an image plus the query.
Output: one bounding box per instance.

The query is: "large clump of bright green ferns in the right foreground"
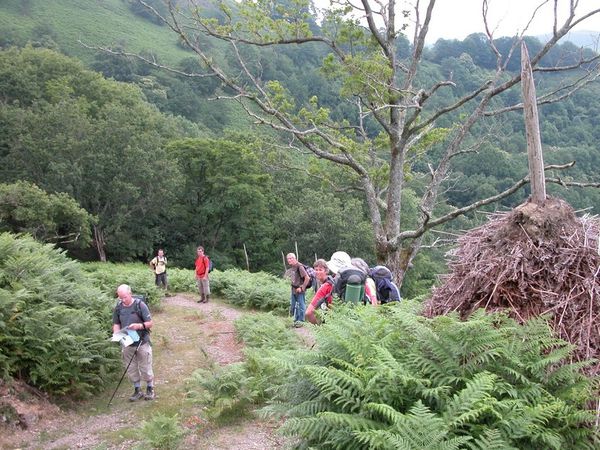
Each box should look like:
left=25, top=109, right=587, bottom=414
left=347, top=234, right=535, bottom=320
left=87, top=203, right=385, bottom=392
left=266, top=302, right=598, bottom=449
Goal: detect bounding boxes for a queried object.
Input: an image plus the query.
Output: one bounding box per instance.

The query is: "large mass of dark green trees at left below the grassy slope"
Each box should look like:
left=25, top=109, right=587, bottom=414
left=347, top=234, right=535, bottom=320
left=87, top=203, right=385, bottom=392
left=0, top=48, right=195, bottom=260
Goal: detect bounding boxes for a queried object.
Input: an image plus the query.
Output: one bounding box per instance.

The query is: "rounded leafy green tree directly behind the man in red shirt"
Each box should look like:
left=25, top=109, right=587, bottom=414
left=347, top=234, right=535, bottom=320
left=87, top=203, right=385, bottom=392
left=168, top=139, right=280, bottom=270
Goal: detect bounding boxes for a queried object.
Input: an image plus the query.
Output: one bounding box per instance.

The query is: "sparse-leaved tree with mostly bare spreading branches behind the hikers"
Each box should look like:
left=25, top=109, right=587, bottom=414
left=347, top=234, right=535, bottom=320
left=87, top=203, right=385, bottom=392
left=97, top=0, right=600, bottom=283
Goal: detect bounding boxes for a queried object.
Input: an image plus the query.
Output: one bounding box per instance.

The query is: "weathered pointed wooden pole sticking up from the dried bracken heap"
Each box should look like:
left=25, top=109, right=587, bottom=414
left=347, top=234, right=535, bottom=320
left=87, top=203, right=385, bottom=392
left=521, top=41, right=546, bottom=205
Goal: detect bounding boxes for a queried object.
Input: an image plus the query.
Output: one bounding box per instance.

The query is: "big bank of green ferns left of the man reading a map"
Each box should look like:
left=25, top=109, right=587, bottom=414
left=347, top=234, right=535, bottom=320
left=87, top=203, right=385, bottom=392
left=0, top=233, right=120, bottom=397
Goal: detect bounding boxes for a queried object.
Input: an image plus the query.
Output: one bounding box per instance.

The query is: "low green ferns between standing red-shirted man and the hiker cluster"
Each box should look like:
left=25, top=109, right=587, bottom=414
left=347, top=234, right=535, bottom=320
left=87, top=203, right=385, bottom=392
left=211, top=269, right=290, bottom=312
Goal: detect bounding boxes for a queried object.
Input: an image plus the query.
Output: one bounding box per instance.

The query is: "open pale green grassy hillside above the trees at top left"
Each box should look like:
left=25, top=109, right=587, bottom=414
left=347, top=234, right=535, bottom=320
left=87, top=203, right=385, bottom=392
left=0, top=0, right=191, bottom=64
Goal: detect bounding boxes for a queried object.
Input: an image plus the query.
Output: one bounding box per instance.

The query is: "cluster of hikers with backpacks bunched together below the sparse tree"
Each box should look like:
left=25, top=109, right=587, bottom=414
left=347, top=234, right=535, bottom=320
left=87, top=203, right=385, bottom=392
left=286, top=252, right=401, bottom=327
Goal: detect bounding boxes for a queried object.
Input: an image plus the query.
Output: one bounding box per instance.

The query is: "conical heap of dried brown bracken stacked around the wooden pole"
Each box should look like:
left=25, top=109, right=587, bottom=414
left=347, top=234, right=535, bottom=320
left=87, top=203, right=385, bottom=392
left=425, top=198, right=600, bottom=374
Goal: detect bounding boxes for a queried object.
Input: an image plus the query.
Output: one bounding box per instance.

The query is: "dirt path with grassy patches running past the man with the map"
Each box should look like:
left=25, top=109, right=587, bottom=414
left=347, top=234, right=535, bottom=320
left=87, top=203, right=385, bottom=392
left=0, top=294, right=296, bottom=450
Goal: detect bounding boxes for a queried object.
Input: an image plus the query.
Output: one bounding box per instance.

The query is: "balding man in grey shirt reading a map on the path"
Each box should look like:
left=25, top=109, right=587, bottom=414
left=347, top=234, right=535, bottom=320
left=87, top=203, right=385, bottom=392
left=112, top=284, right=154, bottom=402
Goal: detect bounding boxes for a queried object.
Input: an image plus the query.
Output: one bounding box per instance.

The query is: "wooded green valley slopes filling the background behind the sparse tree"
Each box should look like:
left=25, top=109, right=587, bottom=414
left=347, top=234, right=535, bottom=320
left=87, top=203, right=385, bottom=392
left=0, top=0, right=600, bottom=295
